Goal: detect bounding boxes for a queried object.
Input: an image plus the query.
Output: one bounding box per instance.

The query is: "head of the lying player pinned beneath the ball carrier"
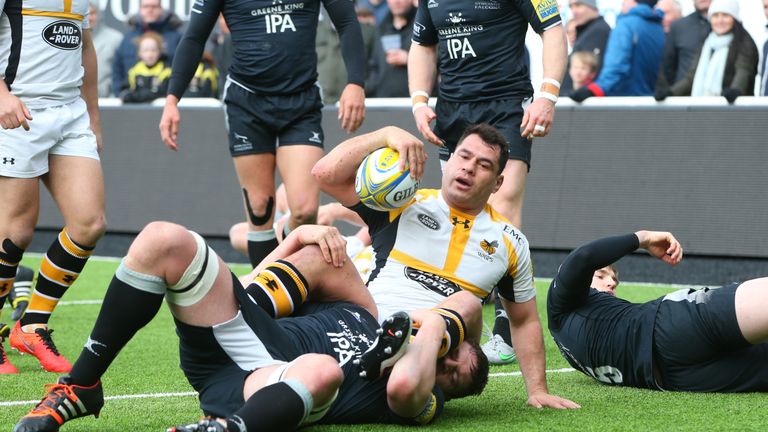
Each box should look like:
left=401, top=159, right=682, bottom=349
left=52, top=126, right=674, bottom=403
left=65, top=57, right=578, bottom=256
left=435, top=341, right=488, bottom=399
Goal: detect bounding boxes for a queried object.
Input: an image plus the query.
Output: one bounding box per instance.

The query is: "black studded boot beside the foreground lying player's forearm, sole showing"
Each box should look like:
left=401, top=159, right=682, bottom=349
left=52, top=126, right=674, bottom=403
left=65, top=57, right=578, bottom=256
left=353, top=312, right=412, bottom=381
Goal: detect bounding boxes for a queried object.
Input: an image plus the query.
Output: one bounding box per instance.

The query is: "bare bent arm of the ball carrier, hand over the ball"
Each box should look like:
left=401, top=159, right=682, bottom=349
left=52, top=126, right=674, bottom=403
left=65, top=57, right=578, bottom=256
left=312, top=126, right=427, bottom=207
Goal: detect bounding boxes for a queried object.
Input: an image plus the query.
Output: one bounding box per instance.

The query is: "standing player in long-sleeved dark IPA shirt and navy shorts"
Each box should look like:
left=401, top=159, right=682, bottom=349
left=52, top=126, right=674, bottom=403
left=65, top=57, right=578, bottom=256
left=160, top=0, right=365, bottom=267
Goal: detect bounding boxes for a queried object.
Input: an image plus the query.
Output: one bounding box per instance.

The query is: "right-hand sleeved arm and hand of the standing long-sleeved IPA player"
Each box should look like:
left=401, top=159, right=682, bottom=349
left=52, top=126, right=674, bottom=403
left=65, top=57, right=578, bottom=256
left=323, top=0, right=366, bottom=133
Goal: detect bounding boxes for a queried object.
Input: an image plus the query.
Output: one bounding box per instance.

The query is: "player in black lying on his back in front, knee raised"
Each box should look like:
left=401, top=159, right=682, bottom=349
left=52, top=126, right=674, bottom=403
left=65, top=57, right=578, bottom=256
left=14, top=222, right=488, bottom=432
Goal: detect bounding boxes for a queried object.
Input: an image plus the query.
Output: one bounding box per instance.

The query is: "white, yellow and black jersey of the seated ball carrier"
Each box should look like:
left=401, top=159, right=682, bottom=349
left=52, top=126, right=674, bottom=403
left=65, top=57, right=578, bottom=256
left=352, top=189, right=536, bottom=317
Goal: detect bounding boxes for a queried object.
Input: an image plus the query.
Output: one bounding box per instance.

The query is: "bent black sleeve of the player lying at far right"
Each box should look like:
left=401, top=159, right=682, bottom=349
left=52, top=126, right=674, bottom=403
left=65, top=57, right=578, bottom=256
left=547, top=234, right=640, bottom=313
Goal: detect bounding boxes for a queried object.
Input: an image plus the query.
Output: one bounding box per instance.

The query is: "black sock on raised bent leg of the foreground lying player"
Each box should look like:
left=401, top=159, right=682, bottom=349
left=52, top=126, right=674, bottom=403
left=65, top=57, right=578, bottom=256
left=70, top=276, right=164, bottom=386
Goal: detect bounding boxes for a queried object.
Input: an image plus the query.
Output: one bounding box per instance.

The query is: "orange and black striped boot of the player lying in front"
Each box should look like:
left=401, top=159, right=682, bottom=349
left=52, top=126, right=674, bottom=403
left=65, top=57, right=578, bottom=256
left=13, top=376, right=104, bottom=432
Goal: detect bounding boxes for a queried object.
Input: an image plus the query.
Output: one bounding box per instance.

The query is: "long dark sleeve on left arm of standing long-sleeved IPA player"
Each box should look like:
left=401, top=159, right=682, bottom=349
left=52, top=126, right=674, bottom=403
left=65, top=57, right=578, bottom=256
left=168, top=0, right=223, bottom=99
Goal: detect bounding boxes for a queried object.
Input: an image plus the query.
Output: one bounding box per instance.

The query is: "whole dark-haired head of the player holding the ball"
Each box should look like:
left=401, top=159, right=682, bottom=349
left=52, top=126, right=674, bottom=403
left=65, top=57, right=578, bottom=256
left=442, top=124, right=508, bottom=212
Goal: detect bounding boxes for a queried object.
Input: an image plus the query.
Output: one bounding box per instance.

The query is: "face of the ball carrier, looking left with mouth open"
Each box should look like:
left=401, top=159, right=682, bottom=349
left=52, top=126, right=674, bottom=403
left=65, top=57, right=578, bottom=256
left=442, top=135, right=503, bottom=211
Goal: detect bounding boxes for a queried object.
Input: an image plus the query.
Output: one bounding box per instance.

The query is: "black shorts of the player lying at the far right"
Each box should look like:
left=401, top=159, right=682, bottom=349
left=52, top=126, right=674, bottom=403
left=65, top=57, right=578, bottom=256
left=654, top=283, right=768, bottom=392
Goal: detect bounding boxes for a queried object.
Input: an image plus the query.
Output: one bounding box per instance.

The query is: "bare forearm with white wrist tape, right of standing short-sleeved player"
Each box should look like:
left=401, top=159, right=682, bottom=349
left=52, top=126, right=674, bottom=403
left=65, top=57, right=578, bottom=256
left=520, top=24, right=568, bottom=137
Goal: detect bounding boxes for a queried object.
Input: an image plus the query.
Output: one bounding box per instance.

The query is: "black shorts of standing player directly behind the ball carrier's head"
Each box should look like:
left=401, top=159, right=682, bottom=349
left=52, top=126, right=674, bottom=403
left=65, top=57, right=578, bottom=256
left=435, top=97, right=531, bottom=169
